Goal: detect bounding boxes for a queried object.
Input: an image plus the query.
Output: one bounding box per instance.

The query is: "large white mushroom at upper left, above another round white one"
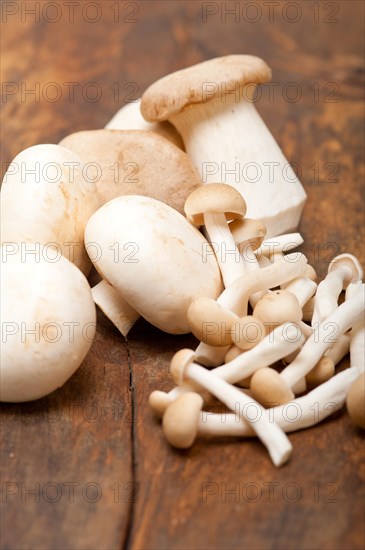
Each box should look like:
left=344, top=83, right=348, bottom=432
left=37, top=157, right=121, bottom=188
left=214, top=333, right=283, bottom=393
left=1, top=144, right=100, bottom=274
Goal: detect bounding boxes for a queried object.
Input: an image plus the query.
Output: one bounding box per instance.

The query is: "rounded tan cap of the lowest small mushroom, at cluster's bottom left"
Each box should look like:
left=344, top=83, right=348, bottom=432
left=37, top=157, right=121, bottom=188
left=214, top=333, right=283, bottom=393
left=162, top=392, right=204, bottom=449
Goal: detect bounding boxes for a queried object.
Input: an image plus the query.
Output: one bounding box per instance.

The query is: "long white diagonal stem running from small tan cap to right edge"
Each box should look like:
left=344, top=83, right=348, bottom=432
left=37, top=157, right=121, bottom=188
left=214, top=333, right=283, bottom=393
left=280, top=285, right=365, bottom=388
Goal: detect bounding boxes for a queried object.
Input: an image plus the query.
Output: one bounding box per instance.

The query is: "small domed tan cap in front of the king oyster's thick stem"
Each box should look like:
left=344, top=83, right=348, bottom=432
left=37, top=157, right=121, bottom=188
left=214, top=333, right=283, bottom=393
left=184, top=183, right=246, bottom=226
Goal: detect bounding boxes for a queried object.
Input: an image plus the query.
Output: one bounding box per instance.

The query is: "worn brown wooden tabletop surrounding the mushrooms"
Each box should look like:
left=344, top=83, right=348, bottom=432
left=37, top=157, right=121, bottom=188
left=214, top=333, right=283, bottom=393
left=1, top=0, right=365, bottom=550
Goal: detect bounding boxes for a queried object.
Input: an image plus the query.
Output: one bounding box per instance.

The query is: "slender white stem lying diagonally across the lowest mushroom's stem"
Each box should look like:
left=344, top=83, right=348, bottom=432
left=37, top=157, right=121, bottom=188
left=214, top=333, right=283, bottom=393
left=178, top=363, right=292, bottom=466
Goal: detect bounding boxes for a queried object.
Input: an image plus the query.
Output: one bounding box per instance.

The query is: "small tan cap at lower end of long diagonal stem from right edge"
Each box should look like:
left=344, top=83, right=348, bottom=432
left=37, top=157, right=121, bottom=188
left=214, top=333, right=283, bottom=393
left=250, top=367, right=294, bottom=408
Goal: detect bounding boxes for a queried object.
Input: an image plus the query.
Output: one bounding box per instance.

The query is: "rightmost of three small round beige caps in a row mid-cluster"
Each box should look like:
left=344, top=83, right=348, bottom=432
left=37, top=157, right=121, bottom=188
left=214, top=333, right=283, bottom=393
left=252, top=290, right=303, bottom=327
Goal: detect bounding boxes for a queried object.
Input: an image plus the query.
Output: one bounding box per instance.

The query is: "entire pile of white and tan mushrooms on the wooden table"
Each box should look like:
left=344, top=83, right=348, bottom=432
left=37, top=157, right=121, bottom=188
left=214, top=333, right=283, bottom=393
left=1, top=55, right=365, bottom=466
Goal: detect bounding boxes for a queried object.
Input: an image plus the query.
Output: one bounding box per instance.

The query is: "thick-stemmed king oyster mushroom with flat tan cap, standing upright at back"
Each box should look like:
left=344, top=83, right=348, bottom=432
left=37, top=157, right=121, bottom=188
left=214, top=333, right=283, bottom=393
left=141, top=55, right=306, bottom=236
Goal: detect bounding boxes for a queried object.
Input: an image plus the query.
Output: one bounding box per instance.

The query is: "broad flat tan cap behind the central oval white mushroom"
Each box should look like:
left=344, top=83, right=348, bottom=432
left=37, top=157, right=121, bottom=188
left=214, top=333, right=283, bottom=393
left=60, top=130, right=202, bottom=214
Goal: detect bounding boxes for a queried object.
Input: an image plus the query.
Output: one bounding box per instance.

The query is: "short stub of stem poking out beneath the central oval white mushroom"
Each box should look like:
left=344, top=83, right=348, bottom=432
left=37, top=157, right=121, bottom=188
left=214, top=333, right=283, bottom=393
left=91, top=279, right=140, bottom=337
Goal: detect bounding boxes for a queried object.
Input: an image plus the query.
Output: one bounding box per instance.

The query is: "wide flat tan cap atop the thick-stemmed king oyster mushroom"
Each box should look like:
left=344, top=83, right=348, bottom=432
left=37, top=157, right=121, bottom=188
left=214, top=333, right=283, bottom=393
left=141, top=55, right=271, bottom=121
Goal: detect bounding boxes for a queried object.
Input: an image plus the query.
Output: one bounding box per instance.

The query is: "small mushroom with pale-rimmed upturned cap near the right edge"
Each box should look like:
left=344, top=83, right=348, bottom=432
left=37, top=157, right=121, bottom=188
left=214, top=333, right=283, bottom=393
left=312, top=254, right=362, bottom=326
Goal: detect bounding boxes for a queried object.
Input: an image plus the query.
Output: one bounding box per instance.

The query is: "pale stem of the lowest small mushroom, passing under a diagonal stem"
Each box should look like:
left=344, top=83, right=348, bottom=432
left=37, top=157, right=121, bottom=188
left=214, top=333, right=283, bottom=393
left=198, top=367, right=359, bottom=437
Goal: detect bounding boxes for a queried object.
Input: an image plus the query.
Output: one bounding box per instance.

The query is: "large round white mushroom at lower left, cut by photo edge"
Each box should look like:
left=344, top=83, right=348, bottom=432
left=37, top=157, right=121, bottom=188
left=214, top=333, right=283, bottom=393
left=0, top=247, right=96, bottom=402
